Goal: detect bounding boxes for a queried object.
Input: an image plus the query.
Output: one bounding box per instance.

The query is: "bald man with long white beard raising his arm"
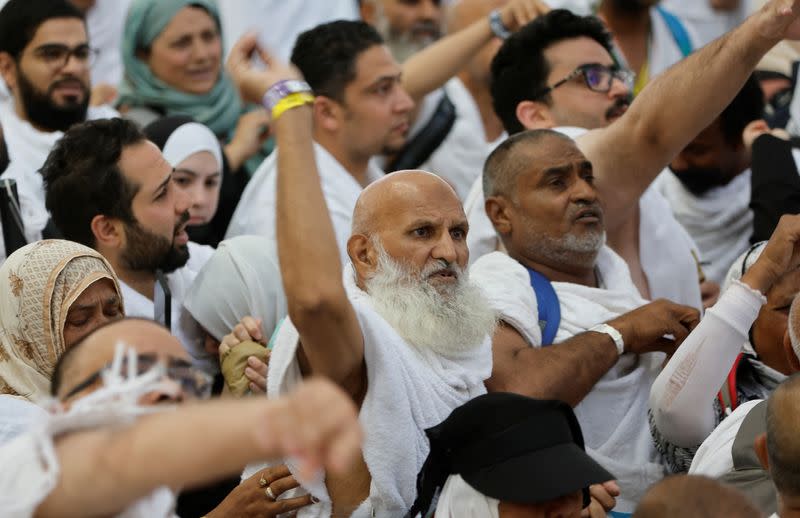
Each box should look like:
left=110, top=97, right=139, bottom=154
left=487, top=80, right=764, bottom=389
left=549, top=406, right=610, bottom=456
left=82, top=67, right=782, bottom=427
left=226, top=37, right=496, bottom=516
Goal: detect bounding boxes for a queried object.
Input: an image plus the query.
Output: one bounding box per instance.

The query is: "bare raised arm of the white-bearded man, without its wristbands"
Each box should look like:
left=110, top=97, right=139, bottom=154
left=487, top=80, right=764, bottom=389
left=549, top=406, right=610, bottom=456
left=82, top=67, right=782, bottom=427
left=223, top=36, right=366, bottom=395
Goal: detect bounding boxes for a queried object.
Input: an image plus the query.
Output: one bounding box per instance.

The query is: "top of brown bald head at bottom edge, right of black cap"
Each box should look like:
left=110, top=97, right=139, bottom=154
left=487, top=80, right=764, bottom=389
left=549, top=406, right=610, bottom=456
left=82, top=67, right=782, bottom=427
left=633, top=475, right=761, bottom=518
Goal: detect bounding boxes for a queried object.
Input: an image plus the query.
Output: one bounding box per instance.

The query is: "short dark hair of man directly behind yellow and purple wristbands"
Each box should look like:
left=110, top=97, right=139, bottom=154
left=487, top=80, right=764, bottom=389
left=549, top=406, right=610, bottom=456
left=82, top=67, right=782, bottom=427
left=292, top=20, right=383, bottom=103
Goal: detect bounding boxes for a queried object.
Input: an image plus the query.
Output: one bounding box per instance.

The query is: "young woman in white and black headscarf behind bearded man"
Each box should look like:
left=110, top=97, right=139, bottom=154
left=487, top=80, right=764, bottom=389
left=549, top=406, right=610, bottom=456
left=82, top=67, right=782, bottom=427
left=144, top=115, right=238, bottom=247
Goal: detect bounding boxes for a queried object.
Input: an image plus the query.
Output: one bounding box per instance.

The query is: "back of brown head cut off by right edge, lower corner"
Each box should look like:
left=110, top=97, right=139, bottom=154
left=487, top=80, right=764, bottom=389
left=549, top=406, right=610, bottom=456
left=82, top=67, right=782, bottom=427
left=767, top=374, right=800, bottom=498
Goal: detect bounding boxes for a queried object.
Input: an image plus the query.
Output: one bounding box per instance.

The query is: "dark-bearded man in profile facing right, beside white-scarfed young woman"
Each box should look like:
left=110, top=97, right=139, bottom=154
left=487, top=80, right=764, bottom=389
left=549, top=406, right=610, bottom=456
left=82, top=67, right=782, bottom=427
left=42, top=118, right=218, bottom=373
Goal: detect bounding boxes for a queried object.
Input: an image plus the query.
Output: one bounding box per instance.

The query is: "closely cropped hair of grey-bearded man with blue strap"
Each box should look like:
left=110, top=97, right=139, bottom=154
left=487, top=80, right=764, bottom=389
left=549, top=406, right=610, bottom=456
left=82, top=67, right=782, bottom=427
left=483, top=129, right=574, bottom=200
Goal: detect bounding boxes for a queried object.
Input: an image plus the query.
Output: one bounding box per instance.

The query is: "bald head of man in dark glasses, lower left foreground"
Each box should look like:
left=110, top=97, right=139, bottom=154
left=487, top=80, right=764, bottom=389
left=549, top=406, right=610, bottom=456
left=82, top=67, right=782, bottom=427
left=51, top=318, right=188, bottom=399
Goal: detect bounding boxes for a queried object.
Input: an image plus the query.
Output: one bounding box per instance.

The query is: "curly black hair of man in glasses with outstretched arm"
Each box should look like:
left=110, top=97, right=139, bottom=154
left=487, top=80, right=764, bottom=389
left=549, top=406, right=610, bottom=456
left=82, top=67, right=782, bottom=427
left=490, top=9, right=613, bottom=134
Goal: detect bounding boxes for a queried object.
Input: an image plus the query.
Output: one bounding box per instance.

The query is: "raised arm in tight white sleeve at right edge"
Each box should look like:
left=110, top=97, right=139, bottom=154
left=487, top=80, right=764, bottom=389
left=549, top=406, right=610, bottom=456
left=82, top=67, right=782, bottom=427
left=650, top=216, right=800, bottom=448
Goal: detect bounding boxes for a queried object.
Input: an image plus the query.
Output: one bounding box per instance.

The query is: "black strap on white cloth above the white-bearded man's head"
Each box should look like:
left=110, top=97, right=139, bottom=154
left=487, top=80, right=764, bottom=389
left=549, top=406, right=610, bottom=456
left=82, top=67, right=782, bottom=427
left=386, top=90, right=456, bottom=173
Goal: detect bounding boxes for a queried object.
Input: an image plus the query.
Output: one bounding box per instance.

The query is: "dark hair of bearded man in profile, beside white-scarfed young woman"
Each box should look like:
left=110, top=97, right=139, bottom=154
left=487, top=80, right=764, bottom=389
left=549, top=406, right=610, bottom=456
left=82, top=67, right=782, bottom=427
left=40, top=118, right=146, bottom=247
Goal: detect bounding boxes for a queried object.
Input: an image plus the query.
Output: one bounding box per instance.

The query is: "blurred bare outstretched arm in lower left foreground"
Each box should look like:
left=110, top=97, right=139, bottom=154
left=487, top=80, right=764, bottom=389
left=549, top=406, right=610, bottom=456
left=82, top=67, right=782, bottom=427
left=31, top=380, right=361, bottom=518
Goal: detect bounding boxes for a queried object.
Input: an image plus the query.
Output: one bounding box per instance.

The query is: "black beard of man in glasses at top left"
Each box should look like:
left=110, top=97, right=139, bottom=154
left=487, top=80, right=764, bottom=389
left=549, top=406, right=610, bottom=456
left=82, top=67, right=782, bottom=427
left=17, top=66, right=90, bottom=131
